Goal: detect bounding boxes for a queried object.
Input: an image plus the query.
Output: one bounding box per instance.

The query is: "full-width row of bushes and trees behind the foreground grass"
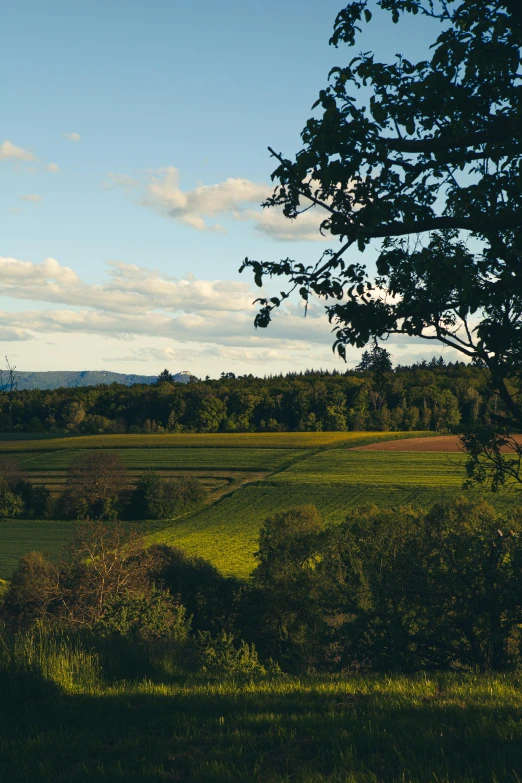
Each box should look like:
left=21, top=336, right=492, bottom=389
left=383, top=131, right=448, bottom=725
left=4, top=498, right=522, bottom=677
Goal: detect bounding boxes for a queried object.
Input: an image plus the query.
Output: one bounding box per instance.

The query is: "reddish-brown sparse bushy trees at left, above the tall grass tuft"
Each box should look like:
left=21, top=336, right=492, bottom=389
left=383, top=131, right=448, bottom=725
left=2, top=520, right=172, bottom=636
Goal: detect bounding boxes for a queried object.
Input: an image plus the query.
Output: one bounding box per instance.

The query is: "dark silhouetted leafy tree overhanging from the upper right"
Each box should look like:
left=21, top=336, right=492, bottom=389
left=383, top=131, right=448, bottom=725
left=241, top=0, right=522, bottom=480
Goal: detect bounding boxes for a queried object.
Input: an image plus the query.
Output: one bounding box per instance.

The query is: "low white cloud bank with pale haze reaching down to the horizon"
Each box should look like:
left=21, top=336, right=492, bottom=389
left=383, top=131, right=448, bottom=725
left=0, top=258, right=456, bottom=376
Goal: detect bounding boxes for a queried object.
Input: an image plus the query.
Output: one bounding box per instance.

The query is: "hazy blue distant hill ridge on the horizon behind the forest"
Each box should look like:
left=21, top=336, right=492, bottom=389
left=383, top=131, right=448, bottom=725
left=11, top=370, right=191, bottom=390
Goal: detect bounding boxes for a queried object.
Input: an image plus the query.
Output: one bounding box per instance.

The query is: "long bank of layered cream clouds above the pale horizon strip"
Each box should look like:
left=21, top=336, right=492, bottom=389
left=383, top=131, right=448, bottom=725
left=0, top=258, right=336, bottom=352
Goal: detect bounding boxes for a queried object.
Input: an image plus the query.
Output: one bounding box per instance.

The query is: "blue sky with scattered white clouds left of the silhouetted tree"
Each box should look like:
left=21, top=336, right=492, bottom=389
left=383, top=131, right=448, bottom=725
left=0, top=0, right=453, bottom=377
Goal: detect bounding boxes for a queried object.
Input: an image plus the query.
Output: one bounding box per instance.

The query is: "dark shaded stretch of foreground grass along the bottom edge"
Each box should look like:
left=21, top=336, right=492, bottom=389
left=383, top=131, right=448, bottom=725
left=0, top=680, right=522, bottom=783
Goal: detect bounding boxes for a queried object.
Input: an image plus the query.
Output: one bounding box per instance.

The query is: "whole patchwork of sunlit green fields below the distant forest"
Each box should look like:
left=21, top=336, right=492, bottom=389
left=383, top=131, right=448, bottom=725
left=0, top=432, right=520, bottom=579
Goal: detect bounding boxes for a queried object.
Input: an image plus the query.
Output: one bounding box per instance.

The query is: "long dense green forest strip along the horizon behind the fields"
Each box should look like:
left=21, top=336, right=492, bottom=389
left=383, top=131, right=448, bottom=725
left=0, top=354, right=501, bottom=434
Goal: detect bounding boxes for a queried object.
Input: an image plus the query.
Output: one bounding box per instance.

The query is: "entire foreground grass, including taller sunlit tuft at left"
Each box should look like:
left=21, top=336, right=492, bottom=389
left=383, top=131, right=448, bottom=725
left=0, top=630, right=522, bottom=783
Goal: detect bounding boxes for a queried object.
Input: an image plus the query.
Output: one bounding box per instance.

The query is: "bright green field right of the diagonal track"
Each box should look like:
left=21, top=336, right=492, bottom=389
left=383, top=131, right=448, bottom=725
left=150, top=448, right=521, bottom=578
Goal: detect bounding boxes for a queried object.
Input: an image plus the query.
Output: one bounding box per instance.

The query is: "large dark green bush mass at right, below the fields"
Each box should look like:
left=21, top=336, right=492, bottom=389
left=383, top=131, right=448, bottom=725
left=251, top=498, right=522, bottom=671
